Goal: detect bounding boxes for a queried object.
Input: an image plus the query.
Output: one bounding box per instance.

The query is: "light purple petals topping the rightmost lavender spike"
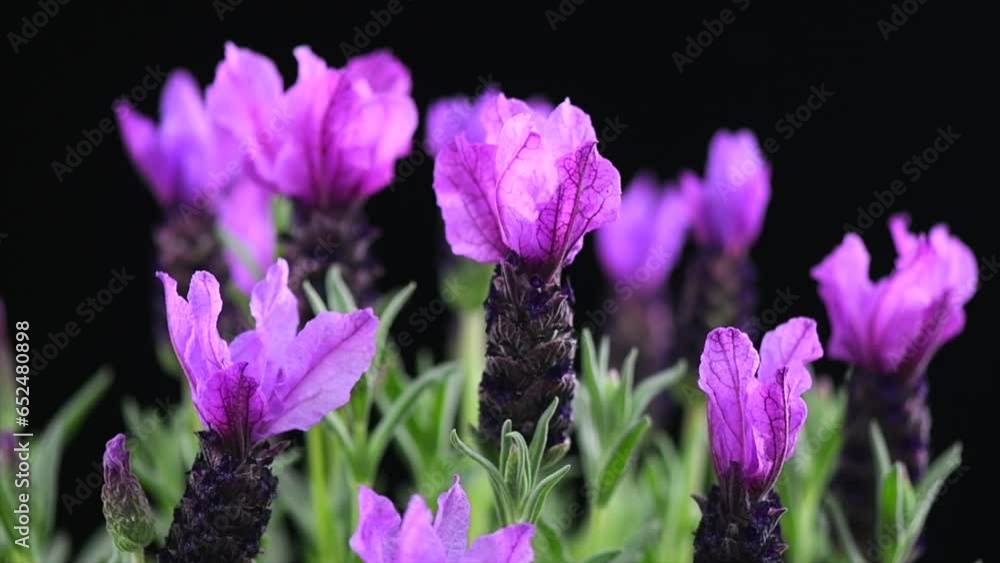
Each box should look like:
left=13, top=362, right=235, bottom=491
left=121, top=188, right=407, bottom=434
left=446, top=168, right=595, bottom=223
left=812, top=215, right=978, bottom=373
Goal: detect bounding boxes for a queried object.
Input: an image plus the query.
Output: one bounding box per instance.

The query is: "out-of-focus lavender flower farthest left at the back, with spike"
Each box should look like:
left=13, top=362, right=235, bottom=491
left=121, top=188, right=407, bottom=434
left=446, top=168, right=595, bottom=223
left=116, top=70, right=275, bottom=300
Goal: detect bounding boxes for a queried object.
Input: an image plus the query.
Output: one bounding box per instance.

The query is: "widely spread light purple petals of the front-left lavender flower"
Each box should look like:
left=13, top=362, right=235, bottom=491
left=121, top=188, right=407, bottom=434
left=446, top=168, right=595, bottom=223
left=157, top=259, right=378, bottom=441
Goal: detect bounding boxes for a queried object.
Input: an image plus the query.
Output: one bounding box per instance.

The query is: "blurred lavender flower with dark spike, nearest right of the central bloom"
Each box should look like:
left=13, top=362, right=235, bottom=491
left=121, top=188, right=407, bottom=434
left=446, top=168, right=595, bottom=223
left=597, top=174, right=690, bottom=375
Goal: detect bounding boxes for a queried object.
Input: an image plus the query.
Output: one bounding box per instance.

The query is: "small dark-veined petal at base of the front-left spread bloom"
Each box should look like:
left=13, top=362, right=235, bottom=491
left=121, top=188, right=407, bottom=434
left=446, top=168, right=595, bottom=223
left=192, top=362, right=265, bottom=442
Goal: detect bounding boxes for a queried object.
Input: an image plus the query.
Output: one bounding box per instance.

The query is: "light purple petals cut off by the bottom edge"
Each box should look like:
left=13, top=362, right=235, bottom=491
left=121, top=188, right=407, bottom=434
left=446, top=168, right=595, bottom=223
left=351, top=475, right=535, bottom=563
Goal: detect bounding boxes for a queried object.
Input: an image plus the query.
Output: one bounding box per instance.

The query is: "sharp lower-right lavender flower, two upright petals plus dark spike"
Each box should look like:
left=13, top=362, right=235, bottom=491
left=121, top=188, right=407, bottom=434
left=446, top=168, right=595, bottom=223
left=695, top=317, right=823, bottom=562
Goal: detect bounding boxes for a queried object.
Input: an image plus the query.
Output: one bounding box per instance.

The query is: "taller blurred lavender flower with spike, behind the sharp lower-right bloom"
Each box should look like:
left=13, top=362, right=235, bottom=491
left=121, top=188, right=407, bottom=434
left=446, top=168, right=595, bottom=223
left=679, top=130, right=771, bottom=361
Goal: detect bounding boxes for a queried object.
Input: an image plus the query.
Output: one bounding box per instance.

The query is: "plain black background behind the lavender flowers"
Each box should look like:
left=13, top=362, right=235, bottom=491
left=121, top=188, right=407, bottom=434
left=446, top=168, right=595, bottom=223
left=0, top=0, right=988, bottom=561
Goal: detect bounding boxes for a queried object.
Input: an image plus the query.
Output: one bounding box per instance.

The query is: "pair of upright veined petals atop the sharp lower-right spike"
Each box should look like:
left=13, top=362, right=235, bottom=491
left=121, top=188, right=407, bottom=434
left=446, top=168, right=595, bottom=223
left=698, top=317, right=823, bottom=497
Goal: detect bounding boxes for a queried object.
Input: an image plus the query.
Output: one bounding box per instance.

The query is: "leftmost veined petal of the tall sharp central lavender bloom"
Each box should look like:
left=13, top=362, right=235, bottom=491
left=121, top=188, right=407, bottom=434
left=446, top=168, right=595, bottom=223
left=434, top=136, right=507, bottom=262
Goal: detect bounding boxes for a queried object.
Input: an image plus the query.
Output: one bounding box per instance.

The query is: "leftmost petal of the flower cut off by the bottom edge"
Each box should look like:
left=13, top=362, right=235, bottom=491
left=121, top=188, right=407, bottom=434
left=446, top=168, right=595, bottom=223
left=350, top=485, right=402, bottom=563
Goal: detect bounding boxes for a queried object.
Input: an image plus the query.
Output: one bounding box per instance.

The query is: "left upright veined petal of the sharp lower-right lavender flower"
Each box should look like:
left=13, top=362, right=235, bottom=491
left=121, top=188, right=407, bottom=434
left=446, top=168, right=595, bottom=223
left=698, top=327, right=760, bottom=478
